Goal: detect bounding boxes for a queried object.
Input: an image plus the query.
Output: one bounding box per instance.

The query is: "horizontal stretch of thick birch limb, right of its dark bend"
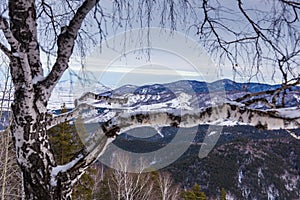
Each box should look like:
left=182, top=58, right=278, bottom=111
left=99, top=103, right=300, bottom=137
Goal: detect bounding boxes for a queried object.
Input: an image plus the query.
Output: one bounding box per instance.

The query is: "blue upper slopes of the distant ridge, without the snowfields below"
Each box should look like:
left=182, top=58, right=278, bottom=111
left=102, top=79, right=300, bottom=107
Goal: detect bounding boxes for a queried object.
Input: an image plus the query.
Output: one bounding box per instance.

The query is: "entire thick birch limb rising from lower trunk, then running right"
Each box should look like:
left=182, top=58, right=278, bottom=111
left=51, top=100, right=300, bottom=191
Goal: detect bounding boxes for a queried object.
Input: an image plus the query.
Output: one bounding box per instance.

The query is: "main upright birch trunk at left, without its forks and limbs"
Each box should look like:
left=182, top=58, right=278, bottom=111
left=9, top=1, right=54, bottom=199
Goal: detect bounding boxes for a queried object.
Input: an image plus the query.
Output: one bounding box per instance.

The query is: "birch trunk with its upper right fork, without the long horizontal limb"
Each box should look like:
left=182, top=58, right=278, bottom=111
left=4, top=0, right=98, bottom=199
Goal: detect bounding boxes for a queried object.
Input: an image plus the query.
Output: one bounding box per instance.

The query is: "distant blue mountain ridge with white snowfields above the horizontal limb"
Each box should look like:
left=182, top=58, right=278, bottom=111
left=86, top=79, right=300, bottom=109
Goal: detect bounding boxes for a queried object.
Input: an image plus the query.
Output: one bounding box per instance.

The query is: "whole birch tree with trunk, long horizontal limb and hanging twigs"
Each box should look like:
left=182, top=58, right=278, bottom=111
left=0, top=0, right=300, bottom=199
